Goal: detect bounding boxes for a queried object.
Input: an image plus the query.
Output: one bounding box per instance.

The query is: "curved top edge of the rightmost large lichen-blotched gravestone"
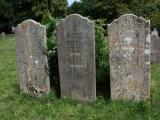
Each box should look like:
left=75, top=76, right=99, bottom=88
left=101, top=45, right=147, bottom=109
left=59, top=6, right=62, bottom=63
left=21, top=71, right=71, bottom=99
left=107, top=14, right=150, bottom=26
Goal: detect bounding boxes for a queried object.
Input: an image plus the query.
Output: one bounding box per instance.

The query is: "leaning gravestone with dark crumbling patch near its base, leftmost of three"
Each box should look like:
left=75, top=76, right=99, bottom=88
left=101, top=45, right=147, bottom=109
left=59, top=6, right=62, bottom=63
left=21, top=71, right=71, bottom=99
left=15, top=20, right=50, bottom=96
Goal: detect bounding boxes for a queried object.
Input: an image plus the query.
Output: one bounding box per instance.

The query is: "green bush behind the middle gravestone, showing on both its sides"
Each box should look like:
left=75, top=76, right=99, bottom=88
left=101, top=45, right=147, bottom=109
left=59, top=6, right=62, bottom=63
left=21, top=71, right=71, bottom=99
left=45, top=17, right=109, bottom=95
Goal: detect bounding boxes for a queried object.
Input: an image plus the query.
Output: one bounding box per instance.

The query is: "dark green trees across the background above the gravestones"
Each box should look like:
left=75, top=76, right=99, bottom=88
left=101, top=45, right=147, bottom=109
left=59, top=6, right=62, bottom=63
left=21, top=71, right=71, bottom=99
left=0, top=0, right=160, bottom=33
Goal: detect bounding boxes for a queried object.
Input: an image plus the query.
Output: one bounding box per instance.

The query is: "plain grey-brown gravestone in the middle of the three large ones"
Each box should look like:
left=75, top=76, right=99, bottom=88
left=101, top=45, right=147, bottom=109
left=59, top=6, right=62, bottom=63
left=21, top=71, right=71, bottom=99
left=57, top=14, right=96, bottom=102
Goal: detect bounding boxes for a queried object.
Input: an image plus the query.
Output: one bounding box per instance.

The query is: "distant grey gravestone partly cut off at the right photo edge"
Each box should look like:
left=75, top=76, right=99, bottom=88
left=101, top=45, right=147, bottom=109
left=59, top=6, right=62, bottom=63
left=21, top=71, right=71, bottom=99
left=151, top=29, right=160, bottom=64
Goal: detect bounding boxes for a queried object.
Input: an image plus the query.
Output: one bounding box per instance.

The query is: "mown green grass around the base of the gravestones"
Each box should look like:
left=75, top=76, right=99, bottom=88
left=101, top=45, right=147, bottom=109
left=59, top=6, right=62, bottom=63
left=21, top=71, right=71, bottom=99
left=0, top=36, right=160, bottom=120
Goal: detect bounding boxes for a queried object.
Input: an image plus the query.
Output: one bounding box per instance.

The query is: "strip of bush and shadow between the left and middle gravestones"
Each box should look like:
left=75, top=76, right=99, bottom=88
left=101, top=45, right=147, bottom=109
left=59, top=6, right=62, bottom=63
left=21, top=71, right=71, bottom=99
left=42, top=13, right=60, bottom=95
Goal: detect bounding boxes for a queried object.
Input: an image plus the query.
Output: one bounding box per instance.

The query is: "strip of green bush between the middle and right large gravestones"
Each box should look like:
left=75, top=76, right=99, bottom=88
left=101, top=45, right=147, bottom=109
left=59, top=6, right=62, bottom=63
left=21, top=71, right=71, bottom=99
left=95, top=19, right=109, bottom=81
